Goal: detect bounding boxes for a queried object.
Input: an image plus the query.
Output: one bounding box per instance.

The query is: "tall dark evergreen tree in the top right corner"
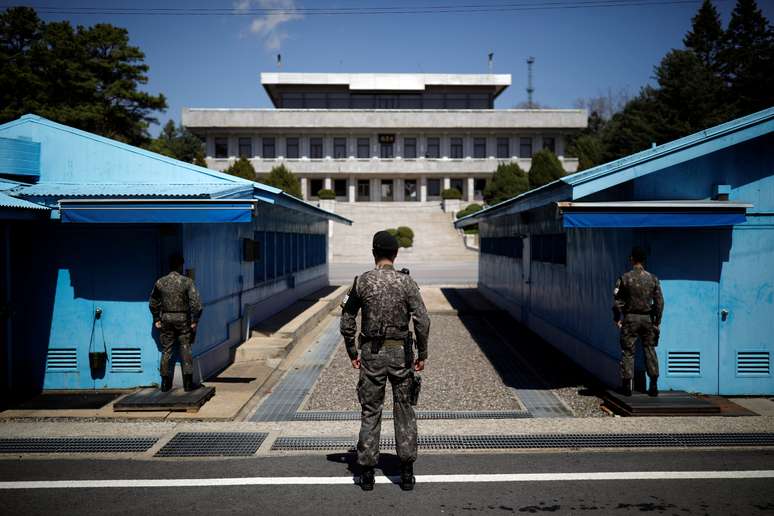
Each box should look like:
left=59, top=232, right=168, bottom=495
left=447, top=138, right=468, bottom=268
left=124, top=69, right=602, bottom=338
left=720, top=0, right=774, bottom=116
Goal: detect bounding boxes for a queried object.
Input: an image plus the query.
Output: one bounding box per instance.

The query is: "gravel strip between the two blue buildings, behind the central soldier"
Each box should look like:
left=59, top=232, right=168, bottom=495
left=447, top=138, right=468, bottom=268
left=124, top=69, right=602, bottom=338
left=303, top=315, right=523, bottom=411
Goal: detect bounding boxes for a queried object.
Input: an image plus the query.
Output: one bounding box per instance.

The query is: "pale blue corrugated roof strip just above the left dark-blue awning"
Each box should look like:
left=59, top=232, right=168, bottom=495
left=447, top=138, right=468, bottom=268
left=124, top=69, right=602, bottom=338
left=19, top=183, right=253, bottom=199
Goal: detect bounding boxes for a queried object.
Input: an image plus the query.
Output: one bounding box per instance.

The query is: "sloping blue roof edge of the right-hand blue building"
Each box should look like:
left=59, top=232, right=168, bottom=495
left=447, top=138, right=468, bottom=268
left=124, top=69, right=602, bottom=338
left=454, top=107, right=774, bottom=228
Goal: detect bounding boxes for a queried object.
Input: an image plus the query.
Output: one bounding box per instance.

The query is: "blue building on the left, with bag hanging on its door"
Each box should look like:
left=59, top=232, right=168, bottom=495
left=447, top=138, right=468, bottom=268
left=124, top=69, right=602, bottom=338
left=0, top=115, right=349, bottom=391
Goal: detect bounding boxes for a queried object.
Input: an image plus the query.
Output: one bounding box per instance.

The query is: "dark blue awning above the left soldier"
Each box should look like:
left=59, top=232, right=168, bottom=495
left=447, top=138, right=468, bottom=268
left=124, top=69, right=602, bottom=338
left=59, top=199, right=256, bottom=224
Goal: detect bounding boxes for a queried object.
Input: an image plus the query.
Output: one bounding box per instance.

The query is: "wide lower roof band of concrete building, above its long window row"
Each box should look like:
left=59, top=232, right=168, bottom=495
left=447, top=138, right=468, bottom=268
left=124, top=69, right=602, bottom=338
left=182, top=108, right=588, bottom=131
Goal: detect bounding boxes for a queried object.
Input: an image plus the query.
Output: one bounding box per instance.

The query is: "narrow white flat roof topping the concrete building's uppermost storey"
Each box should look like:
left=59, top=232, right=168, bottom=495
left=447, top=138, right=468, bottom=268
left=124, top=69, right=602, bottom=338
left=261, top=72, right=511, bottom=105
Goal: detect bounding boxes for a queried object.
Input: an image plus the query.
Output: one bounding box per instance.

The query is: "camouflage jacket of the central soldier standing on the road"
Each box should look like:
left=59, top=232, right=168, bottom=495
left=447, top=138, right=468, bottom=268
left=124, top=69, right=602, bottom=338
left=341, top=266, right=430, bottom=360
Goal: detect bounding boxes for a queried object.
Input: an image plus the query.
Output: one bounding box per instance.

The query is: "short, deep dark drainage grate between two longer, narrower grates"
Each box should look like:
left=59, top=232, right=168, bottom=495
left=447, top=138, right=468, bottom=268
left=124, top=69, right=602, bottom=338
left=156, top=432, right=269, bottom=457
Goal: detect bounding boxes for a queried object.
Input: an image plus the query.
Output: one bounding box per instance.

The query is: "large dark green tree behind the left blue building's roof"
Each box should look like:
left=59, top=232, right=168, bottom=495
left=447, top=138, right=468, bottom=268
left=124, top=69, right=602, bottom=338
left=0, top=7, right=167, bottom=145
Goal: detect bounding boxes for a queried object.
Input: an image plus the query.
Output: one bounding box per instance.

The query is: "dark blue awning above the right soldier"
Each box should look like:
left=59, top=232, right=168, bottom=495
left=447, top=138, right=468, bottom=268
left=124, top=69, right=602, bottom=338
left=564, top=212, right=747, bottom=228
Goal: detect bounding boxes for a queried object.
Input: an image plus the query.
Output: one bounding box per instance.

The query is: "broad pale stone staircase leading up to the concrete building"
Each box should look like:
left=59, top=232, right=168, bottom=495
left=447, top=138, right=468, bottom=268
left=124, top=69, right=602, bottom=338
left=331, top=202, right=478, bottom=264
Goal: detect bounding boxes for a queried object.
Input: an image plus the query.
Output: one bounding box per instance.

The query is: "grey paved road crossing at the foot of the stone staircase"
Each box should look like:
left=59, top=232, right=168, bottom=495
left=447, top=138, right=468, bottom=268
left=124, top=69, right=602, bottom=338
left=328, top=262, right=478, bottom=285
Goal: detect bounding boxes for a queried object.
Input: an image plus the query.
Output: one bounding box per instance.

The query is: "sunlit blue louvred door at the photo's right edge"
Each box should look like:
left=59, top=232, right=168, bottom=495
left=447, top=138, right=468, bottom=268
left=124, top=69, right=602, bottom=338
left=718, top=226, right=774, bottom=394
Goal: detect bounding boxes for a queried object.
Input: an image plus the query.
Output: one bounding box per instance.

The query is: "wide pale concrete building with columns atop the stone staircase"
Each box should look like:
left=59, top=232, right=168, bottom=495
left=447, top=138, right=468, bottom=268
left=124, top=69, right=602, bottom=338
left=183, top=73, right=587, bottom=202
